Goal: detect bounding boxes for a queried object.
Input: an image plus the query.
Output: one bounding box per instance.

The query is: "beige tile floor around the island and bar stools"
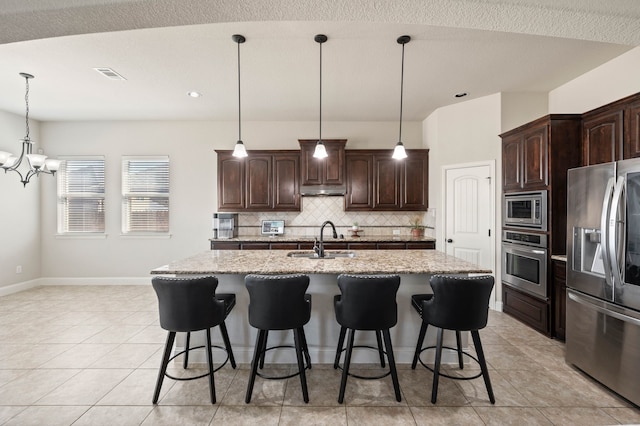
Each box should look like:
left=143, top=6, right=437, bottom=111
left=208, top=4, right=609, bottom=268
left=0, top=286, right=640, bottom=426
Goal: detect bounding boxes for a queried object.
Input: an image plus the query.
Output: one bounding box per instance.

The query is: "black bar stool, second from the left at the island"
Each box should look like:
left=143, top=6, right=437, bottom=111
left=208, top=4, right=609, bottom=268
left=245, top=274, right=311, bottom=403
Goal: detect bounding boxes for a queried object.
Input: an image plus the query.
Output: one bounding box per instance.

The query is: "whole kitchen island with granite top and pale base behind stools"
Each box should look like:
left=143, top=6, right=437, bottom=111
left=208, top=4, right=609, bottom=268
left=151, top=250, right=491, bottom=363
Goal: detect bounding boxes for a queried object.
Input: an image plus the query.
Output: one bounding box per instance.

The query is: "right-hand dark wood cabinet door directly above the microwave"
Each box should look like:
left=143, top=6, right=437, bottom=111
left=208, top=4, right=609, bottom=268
left=522, top=126, right=549, bottom=189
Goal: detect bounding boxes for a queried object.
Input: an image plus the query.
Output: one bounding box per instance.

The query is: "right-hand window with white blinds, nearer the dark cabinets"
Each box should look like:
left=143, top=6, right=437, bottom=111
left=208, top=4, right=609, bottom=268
left=122, top=156, right=169, bottom=234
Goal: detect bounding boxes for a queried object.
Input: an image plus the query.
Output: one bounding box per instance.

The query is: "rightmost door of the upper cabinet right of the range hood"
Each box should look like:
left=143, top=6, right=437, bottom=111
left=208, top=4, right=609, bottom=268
left=400, top=151, right=429, bottom=211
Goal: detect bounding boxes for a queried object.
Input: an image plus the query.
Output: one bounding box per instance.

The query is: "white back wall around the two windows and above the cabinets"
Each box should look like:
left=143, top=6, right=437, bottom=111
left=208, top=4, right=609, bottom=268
left=41, top=121, right=422, bottom=278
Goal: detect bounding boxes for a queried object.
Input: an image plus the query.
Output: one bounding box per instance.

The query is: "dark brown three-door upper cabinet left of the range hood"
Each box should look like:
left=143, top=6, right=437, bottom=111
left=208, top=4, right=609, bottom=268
left=216, top=150, right=300, bottom=212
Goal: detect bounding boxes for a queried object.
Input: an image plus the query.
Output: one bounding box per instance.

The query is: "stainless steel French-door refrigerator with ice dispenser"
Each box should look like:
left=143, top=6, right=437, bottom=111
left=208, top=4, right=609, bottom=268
left=566, top=159, right=640, bottom=405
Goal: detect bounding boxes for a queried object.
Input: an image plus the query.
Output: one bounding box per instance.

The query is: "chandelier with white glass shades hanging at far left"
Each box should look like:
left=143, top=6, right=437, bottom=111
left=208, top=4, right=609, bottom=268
left=0, top=72, right=60, bottom=186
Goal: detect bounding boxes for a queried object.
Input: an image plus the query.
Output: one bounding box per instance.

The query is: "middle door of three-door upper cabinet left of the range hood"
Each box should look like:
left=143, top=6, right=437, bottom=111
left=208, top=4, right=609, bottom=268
left=245, top=154, right=273, bottom=211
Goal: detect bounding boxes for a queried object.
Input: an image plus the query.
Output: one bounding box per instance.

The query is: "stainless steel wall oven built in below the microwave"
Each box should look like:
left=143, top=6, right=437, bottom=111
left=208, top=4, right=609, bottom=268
left=502, top=230, right=547, bottom=298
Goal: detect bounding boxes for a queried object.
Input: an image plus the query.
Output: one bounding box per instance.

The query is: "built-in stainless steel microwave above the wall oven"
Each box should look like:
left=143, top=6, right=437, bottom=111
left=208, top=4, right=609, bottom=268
left=502, top=190, right=547, bottom=231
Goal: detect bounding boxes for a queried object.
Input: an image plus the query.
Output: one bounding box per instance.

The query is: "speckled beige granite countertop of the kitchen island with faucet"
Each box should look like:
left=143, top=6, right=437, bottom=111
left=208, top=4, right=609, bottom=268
left=151, top=250, right=491, bottom=275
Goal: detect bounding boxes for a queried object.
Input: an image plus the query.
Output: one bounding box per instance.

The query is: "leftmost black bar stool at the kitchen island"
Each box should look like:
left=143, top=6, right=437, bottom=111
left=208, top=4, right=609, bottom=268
left=151, top=277, right=236, bottom=404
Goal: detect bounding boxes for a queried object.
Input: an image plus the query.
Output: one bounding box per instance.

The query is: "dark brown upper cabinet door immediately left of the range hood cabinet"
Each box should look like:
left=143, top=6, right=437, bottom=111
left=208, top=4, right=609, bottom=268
left=273, top=154, right=300, bottom=211
